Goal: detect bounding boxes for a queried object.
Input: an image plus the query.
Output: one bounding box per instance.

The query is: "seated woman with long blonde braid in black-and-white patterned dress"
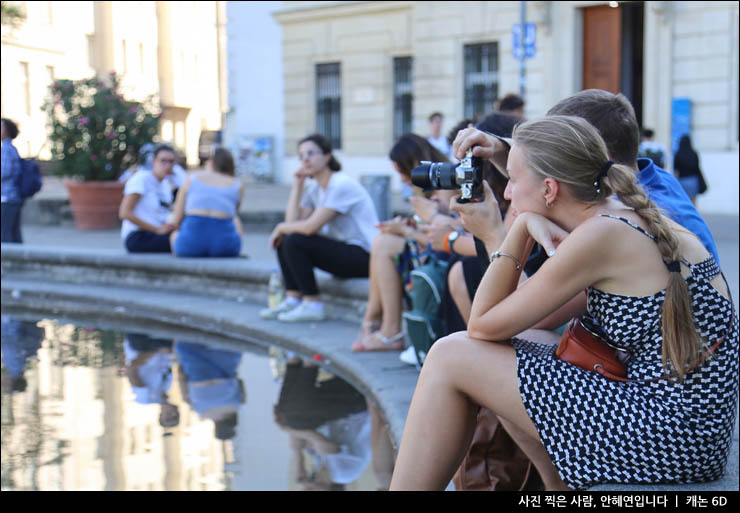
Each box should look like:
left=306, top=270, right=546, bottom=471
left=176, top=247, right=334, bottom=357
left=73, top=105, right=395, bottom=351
left=391, top=116, right=738, bottom=490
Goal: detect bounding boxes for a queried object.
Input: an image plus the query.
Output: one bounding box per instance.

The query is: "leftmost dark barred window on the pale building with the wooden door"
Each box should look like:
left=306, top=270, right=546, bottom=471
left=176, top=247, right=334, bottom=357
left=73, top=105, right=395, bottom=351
left=316, top=62, right=342, bottom=149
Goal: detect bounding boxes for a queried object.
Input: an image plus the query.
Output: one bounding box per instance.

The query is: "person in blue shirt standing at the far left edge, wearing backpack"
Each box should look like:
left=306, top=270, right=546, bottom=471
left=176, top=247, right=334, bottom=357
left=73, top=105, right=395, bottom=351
left=0, top=118, right=23, bottom=242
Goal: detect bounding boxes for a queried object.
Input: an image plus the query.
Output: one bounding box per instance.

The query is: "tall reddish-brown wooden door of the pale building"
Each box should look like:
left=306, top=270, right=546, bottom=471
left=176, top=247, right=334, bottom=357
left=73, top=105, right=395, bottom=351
left=583, top=5, right=622, bottom=93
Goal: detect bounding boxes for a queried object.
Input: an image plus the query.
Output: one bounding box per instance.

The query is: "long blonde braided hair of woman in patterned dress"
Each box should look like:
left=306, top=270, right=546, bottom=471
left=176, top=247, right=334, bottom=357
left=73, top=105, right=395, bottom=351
left=513, top=116, right=704, bottom=380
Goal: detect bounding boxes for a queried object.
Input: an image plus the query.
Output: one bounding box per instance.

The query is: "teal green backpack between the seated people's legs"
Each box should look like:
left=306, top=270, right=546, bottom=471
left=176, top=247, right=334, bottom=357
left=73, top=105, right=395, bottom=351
left=403, top=253, right=449, bottom=365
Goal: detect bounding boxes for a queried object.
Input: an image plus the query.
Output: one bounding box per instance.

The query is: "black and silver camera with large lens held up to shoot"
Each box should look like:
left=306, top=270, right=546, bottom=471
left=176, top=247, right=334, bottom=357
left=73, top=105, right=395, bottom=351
left=411, top=148, right=483, bottom=203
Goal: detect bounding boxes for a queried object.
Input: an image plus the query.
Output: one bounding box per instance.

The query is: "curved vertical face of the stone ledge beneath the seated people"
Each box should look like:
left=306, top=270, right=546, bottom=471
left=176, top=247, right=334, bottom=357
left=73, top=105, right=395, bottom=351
left=0, top=244, right=369, bottom=322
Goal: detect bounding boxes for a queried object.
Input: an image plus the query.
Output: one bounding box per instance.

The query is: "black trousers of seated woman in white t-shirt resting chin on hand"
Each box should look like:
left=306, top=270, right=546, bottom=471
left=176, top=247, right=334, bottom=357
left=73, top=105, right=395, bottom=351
left=277, top=233, right=370, bottom=296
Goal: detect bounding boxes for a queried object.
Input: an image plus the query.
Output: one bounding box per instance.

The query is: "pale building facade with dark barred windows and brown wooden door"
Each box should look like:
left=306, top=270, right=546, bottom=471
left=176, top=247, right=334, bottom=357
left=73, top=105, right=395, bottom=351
left=228, top=1, right=738, bottom=213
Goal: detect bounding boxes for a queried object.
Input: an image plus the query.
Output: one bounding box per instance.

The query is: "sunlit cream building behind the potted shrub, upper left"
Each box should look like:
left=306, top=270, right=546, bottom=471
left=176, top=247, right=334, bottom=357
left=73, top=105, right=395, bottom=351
left=2, top=1, right=225, bottom=164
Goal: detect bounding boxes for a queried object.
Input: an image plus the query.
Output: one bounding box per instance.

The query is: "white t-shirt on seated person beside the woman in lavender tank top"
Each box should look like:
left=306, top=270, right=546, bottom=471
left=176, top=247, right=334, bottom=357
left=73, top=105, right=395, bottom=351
left=121, top=169, right=172, bottom=240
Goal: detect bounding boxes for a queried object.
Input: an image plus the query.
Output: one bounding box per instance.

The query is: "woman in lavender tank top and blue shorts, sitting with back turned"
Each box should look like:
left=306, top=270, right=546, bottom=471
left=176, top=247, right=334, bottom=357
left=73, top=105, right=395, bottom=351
left=170, top=148, right=242, bottom=257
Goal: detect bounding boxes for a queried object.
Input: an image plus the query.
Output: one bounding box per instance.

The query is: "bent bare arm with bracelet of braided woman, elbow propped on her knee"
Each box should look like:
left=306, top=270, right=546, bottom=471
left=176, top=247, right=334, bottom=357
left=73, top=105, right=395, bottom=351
left=468, top=214, right=616, bottom=341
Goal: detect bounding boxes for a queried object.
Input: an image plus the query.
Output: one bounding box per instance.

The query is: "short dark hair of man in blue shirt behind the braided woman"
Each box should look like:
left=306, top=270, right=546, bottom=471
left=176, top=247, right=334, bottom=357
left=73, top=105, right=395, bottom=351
left=547, top=89, right=640, bottom=167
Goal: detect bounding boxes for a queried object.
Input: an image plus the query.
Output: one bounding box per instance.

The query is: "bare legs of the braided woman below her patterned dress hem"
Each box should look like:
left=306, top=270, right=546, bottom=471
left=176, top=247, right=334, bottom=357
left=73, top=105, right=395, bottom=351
left=391, top=332, right=563, bottom=490
